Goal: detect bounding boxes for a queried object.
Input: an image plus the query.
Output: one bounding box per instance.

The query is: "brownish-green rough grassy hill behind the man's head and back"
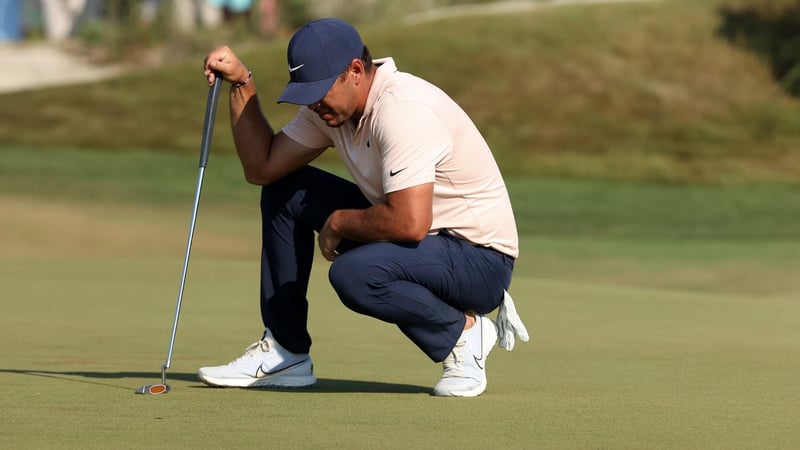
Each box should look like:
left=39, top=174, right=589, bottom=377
left=0, top=0, right=800, bottom=183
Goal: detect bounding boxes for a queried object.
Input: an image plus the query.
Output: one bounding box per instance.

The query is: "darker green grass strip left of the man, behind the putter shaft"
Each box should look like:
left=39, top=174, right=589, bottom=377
left=0, top=145, right=258, bottom=205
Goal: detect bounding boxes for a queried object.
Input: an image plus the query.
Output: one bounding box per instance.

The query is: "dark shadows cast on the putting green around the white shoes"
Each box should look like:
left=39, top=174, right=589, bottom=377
left=0, top=369, right=431, bottom=394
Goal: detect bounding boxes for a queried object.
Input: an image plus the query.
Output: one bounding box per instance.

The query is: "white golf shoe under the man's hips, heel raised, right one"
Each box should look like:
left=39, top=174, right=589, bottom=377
left=433, top=316, right=497, bottom=397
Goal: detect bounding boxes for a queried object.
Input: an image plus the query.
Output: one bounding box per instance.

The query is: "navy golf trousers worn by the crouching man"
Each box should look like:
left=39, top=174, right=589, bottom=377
left=261, top=166, right=514, bottom=362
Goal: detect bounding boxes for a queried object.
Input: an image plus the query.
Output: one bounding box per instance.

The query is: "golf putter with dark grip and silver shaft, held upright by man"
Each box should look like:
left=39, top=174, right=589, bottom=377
left=136, top=74, right=222, bottom=394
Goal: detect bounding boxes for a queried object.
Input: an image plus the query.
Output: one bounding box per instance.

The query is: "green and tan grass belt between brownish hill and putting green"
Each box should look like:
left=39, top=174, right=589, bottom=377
left=0, top=144, right=800, bottom=297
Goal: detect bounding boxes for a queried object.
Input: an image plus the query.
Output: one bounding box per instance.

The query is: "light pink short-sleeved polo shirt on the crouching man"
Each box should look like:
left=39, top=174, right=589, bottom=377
left=283, top=58, right=519, bottom=258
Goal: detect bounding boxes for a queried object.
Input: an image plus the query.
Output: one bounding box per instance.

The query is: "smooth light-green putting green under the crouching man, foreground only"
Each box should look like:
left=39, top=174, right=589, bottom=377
left=0, top=255, right=800, bottom=448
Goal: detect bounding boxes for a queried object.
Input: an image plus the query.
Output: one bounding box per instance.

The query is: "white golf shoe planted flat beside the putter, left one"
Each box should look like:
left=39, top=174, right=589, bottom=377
left=197, top=329, right=317, bottom=388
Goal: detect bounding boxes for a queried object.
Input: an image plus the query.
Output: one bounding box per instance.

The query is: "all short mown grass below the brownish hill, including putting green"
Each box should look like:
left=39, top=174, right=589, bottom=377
left=0, top=149, right=800, bottom=449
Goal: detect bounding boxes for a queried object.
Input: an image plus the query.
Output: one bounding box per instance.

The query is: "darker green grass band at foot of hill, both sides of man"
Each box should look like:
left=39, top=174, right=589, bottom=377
left=0, top=148, right=800, bottom=242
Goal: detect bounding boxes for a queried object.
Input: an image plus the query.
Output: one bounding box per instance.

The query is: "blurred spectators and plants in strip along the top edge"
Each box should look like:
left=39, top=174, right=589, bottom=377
left=0, top=0, right=519, bottom=45
